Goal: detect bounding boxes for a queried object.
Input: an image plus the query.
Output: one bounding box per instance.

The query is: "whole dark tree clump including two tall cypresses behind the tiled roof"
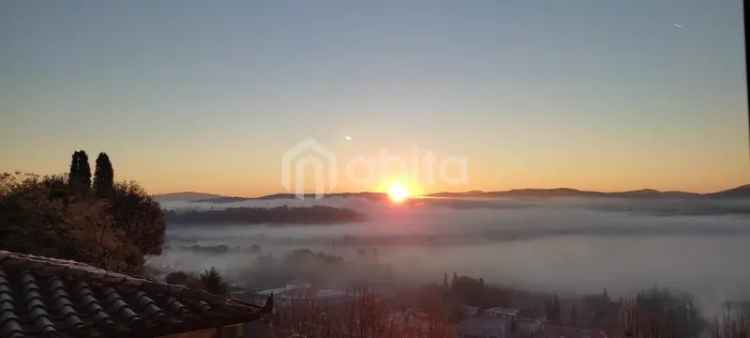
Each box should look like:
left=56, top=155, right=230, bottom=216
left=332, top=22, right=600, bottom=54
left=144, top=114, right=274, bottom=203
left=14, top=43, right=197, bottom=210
left=0, top=151, right=165, bottom=273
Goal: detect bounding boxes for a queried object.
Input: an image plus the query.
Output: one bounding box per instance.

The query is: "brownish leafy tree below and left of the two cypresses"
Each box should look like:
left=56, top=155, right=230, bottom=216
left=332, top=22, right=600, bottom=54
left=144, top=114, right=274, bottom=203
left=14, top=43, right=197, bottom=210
left=0, top=175, right=143, bottom=273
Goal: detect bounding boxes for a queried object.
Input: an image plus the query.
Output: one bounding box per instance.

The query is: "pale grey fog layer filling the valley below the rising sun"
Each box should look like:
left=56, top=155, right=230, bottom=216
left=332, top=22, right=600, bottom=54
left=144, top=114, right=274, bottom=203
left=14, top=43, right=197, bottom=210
left=150, top=198, right=750, bottom=312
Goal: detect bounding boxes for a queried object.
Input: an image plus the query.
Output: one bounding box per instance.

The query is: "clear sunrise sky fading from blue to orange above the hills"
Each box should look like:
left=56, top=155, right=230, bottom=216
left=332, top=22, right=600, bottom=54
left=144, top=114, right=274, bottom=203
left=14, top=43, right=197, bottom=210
left=0, top=0, right=750, bottom=196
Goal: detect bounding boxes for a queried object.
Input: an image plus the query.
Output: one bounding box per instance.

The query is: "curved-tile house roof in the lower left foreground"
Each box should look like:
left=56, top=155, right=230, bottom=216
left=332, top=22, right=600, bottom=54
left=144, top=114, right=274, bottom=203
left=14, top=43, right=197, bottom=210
left=0, top=250, right=272, bottom=338
